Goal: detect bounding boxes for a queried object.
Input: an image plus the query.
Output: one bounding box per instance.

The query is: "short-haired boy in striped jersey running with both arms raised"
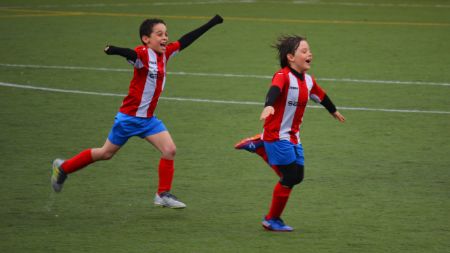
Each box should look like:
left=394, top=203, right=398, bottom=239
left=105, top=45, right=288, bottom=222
left=51, top=15, right=223, bottom=208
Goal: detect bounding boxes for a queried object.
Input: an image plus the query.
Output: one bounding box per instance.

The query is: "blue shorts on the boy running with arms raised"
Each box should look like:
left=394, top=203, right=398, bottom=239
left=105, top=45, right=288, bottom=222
left=108, top=112, right=167, bottom=146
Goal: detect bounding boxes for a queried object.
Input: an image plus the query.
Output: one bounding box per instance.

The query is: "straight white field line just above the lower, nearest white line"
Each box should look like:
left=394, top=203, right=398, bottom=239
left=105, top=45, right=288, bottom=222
left=0, top=63, right=450, bottom=87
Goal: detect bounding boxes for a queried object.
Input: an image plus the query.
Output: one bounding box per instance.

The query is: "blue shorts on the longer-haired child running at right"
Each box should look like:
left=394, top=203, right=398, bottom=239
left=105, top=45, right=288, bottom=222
left=264, top=140, right=305, bottom=166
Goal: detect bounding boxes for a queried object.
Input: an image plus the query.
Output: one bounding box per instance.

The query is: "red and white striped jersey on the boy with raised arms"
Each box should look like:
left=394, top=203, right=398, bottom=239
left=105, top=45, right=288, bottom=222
left=120, top=41, right=180, bottom=118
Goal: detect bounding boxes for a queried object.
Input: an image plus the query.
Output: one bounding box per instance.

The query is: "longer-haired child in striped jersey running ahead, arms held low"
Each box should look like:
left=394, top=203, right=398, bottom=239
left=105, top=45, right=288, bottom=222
left=235, top=36, right=345, bottom=232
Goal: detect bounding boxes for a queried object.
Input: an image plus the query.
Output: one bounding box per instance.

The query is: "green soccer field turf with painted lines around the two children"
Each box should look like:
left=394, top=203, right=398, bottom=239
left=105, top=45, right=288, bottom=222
left=0, top=0, right=450, bottom=253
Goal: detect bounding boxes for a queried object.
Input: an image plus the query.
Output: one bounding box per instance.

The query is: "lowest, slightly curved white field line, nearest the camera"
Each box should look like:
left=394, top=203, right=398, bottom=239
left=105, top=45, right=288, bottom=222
left=0, top=82, right=450, bottom=114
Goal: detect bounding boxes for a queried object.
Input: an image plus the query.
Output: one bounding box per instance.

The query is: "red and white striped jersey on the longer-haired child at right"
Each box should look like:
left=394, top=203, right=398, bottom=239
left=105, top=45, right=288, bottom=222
left=262, top=67, right=325, bottom=144
